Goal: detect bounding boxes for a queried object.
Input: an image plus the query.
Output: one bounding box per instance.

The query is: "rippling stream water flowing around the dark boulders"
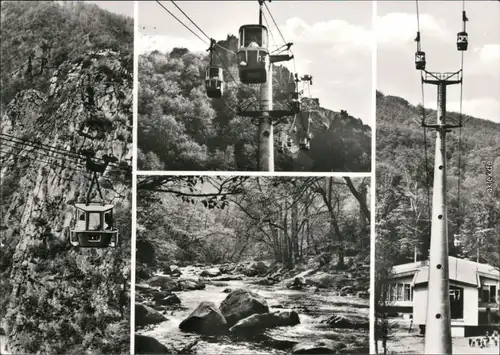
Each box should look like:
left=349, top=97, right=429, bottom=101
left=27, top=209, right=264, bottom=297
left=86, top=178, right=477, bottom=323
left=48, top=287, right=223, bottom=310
left=138, top=267, right=369, bottom=354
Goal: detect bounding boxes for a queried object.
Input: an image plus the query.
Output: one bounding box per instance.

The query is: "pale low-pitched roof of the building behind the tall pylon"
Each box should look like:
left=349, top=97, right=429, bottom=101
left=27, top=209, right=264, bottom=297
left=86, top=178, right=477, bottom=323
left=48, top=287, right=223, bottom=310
left=392, top=256, right=500, bottom=287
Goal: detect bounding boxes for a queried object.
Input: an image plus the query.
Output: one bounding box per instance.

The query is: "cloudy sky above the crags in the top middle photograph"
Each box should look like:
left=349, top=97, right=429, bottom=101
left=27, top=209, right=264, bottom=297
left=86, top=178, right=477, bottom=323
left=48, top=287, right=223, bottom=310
left=139, top=0, right=375, bottom=125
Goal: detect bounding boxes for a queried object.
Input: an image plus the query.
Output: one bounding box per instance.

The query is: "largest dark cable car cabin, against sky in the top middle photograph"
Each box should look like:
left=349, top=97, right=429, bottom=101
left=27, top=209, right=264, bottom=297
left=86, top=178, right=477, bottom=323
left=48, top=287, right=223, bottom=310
left=237, top=25, right=269, bottom=84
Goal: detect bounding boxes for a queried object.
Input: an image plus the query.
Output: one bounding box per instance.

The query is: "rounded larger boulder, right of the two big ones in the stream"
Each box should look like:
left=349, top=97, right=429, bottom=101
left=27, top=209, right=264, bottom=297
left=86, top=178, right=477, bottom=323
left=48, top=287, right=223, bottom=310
left=220, top=288, right=269, bottom=327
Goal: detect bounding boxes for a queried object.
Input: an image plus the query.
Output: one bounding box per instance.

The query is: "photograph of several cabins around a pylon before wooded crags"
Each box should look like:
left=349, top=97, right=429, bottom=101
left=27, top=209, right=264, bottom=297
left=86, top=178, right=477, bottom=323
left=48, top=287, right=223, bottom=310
left=137, top=0, right=375, bottom=172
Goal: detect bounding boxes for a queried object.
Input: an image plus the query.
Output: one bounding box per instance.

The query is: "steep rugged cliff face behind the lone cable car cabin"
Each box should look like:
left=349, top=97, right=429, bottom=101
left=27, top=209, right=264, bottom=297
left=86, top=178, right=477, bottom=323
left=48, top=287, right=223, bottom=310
left=0, top=50, right=132, bottom=354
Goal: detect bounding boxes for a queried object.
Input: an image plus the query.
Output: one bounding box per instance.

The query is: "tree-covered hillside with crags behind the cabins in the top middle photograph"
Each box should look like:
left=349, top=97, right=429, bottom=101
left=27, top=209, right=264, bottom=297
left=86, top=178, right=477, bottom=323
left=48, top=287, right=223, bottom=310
left=138, top=36, right=371, bottom=171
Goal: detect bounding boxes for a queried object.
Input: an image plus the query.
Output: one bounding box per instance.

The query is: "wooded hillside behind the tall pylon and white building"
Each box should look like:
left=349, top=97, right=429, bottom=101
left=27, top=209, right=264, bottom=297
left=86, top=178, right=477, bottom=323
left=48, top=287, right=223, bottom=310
left=377, top=92, right=500, bottom=267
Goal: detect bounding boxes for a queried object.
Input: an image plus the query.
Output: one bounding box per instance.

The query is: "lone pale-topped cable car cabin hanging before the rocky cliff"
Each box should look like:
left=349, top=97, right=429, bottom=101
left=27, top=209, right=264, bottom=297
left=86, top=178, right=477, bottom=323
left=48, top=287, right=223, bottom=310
left=70, top=203, right=118, bottom=248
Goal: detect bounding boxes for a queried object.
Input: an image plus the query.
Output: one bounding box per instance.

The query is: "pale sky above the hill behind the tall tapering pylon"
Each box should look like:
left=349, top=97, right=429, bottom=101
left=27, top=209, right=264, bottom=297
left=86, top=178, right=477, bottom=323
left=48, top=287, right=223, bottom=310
left=375, top=0, right=500, bottom=123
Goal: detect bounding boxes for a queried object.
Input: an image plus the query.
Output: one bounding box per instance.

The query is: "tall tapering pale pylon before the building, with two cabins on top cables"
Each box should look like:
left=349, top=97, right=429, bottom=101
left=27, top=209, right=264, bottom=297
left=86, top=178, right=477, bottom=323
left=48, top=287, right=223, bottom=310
left=415, top=2, right=467, bottom=354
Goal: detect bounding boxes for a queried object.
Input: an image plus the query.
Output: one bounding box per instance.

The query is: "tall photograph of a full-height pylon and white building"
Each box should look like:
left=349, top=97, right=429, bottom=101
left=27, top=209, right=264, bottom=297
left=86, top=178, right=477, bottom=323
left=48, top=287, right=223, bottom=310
left=373, top=1, right=500, bottom=354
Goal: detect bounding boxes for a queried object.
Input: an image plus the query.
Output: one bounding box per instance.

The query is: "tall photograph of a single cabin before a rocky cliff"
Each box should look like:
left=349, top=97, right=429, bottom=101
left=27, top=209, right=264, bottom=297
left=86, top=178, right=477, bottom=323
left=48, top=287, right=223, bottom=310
left=0, top=1, right=134, bottom=355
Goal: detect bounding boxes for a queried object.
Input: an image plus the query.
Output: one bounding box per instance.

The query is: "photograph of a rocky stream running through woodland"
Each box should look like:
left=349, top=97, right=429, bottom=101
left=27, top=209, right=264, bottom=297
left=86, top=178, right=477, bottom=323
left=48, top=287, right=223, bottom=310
left=134, top=175, right=371, bottom=354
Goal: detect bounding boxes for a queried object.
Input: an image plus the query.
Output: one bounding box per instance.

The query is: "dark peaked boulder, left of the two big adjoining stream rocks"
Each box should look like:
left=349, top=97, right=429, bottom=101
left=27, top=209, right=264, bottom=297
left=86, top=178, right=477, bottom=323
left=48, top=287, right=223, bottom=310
left=179, top=302, right=228, bottom=335
